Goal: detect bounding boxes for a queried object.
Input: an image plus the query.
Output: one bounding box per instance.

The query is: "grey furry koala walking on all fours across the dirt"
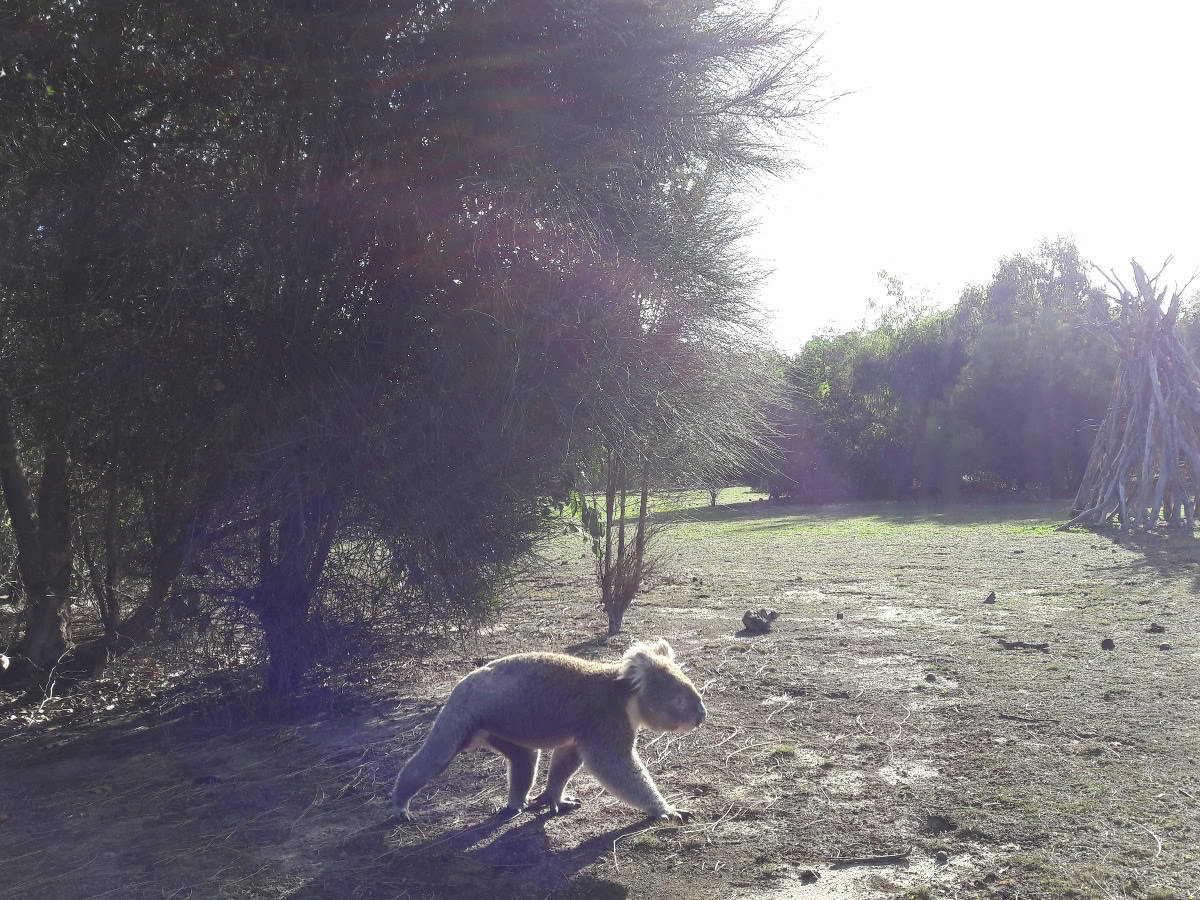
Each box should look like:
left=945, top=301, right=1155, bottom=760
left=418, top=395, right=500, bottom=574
left=391, top=637, right=706, bottom=822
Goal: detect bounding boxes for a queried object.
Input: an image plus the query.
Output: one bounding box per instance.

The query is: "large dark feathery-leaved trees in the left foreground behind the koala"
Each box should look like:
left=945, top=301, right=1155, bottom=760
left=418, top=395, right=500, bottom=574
left=0, top=0, right=817, bottom=695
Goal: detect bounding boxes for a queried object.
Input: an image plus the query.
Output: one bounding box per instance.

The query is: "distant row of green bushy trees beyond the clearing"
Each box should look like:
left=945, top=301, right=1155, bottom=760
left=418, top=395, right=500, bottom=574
left=761, top=241, right=1200, bottom=503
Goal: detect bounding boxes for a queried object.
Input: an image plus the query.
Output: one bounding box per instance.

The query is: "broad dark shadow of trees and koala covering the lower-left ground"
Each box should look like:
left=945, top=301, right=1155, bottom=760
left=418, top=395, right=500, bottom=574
left=0, top=679, right=648, bottom=900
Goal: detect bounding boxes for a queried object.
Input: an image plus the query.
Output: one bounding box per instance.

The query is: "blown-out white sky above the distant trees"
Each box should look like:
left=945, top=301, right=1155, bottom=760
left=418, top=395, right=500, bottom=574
left=750, top=0, right=1200, bottom=350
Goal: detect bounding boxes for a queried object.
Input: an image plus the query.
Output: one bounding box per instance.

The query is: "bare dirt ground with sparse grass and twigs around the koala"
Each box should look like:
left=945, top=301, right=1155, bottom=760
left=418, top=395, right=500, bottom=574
left=0, top=494, right=1200, bottom=900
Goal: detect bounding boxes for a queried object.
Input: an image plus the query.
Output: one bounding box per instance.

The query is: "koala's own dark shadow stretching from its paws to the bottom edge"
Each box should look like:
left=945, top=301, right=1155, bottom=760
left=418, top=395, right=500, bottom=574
left=289, top=814, right=652, bottom=900
